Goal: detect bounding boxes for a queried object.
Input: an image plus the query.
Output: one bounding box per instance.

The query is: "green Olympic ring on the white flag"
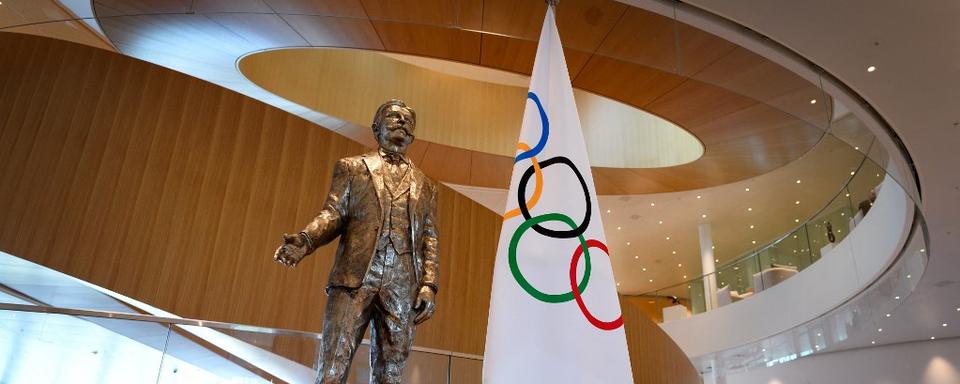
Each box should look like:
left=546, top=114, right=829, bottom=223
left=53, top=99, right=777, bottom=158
left=507, top=213, right=590, bottom=303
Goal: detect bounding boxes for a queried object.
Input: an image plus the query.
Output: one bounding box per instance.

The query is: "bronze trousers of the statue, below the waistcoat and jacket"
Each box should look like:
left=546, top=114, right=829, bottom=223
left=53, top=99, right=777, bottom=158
left=315, top=244, right=419, bottom=384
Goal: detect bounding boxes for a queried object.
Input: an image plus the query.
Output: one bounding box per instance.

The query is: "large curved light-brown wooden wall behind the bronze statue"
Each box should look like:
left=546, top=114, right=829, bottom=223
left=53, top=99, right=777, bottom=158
left=0, top=33, right=689, bottom=383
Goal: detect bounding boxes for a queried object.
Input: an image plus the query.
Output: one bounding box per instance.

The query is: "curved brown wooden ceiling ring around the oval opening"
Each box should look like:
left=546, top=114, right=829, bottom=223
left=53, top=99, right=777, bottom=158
left=16, top=0, right=831, bottom=194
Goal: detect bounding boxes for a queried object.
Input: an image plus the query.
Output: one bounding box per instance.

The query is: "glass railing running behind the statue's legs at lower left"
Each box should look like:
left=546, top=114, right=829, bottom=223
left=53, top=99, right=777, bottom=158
left=0, top=297, right=482, bottom=384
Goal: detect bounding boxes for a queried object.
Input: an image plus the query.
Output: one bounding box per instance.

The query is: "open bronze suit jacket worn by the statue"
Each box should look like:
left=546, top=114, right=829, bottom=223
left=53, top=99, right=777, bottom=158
left=303, top=151, right=440, bottom=292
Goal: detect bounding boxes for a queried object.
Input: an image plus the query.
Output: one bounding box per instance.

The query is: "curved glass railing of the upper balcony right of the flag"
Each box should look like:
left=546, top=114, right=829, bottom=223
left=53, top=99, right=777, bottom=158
left=640, top=132, right=919, bottom=321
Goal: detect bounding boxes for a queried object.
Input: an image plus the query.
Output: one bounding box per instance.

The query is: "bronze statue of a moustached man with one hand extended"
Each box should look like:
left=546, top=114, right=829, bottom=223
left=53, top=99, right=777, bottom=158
left=274, top=100, right=440, bottom=384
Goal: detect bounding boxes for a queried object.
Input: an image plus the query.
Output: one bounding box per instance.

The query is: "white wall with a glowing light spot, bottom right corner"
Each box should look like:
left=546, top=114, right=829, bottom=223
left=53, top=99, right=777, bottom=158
left=721, top=338, right=960, bottom=384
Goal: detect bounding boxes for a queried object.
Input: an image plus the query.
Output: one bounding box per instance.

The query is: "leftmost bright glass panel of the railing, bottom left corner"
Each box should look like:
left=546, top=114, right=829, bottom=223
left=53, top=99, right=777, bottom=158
left=0, top=310, right=169, bottom=384
